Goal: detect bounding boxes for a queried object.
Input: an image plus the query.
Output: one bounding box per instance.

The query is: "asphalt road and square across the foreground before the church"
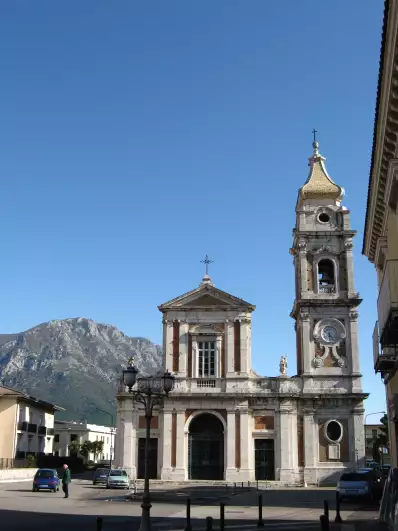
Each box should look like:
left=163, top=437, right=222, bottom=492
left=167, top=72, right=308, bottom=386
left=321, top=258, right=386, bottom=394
left=0, top=479, right=376, bottom=531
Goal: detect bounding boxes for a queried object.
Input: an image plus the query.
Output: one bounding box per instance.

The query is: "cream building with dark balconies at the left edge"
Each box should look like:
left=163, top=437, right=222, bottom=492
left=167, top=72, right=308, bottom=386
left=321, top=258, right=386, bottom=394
left=0, top=386, right=63, bottom=459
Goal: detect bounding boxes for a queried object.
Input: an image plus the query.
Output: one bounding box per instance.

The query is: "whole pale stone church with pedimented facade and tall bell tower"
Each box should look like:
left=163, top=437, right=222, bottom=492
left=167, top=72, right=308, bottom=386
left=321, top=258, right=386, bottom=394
left=115, top=139, right=367, bottom=485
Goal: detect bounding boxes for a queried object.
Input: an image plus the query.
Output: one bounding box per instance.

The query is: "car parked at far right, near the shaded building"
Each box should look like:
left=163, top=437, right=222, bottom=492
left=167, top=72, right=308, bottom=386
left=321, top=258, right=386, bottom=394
left=336, top=468, right=383, bottom=501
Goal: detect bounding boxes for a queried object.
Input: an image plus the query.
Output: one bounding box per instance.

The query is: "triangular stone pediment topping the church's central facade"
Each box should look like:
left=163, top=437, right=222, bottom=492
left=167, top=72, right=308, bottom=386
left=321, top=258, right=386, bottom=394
left=159, top=284, right=256, bottom=312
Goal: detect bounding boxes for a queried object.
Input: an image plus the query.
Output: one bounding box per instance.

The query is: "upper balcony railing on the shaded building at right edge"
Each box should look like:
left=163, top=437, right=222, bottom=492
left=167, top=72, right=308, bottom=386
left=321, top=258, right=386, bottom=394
left=377, top=260, right=398, bottom=346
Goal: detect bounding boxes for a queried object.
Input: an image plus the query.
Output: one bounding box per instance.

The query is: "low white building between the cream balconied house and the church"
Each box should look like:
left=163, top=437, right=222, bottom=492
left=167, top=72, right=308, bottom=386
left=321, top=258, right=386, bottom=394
left=54, top=420, right=116, bottom=461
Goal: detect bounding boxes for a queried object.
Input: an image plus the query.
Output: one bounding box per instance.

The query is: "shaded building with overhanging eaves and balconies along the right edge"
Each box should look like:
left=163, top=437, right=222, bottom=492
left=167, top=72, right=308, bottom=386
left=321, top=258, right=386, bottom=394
left=363, top=0, right=398, bottom=467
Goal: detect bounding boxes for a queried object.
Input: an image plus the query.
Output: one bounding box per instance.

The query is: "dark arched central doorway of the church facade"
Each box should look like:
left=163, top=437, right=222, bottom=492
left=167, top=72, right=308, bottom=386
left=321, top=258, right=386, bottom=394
left=188, top=413, right=224, bottom=480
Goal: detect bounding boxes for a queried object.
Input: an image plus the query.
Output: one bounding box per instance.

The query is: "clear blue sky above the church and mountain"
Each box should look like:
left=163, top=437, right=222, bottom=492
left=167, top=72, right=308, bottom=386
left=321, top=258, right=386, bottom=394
left=0, top=0, right=385, bottom=421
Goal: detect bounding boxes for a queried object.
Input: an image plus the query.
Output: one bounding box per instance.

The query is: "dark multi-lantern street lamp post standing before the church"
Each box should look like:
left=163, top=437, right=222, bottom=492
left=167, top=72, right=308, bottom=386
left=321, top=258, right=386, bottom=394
left=123, top=359, right=175, bottom=531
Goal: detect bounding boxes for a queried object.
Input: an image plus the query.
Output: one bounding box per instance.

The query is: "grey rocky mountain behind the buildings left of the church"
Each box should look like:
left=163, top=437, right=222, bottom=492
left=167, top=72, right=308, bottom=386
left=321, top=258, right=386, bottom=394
left=0, top=318, right=162, bottom=424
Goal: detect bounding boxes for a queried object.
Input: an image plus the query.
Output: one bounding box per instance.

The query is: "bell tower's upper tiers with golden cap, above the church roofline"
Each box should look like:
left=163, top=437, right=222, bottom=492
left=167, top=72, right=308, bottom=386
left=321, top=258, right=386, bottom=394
left=290, top=138, right=361, bottom=386
